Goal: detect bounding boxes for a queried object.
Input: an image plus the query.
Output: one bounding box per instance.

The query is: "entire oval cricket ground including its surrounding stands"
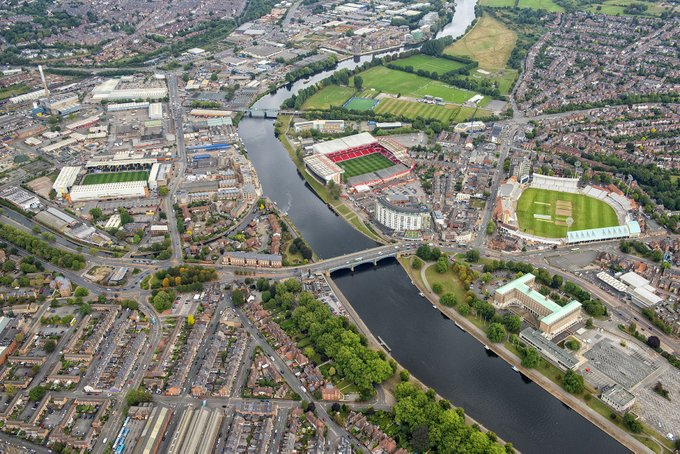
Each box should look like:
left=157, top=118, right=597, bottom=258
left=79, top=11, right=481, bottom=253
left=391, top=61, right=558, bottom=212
left=494, top=174, right=640, bottom=244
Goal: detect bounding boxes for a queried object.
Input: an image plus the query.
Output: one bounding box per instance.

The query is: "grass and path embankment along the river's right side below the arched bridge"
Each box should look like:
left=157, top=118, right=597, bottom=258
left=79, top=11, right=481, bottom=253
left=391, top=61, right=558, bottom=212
left=400, top=255, right=651, bottom=452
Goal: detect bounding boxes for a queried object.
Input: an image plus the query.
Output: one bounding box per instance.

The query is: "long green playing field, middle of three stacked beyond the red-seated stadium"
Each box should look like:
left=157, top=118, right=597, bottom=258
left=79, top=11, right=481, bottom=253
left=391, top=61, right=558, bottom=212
left=350, top=66, right=475, bottom=104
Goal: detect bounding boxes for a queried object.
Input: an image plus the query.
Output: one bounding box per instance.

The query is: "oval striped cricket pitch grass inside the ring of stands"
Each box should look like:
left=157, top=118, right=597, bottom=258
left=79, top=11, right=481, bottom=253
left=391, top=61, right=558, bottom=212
left=517, top=188, right=619, bottom=238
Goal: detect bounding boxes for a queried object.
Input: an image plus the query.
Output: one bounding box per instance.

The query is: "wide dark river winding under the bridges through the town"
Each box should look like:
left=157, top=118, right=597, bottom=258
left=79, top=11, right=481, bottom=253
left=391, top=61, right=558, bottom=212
left=239, top=0, right=627, bottom=454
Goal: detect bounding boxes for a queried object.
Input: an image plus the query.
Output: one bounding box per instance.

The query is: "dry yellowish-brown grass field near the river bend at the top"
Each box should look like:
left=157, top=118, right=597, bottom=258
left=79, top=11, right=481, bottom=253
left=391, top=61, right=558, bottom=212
left=444, top=15, right=517, bottom=71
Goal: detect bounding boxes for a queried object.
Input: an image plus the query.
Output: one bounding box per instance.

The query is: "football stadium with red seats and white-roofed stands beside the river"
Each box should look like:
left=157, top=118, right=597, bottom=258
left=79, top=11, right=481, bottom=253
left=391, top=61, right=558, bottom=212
left=304, top=132, right=415, bottom=191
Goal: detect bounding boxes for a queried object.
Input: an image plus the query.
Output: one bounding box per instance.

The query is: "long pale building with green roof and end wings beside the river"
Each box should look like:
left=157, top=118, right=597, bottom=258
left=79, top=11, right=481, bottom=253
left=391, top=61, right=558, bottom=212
left=493, top=273, right=582, bottom=339
